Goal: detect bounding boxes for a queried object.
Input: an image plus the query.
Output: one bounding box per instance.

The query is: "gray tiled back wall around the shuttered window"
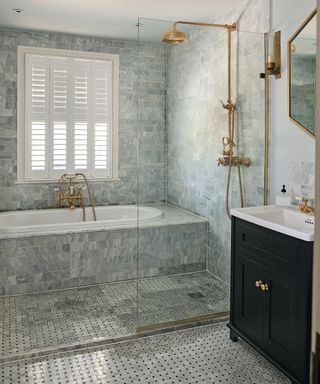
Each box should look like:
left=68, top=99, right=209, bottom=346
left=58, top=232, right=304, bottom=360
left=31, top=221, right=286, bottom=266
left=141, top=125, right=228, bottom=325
left=0, top=30, right=166, bottom=210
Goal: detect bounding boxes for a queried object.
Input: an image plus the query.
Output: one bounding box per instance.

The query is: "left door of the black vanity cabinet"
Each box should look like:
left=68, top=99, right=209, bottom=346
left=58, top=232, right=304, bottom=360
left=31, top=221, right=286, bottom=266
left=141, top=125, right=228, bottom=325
left=232, top=252, right=265, bottom=345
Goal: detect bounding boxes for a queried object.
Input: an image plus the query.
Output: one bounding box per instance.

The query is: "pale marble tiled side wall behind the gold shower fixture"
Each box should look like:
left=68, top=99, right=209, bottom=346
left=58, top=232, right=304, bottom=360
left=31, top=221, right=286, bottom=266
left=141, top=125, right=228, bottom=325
left=167, top=1, right=268, bottom=282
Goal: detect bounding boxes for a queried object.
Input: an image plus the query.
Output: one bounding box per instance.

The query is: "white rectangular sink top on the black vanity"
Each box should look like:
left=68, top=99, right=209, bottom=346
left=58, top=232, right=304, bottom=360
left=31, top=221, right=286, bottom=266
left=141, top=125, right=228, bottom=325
left=231, top=205, right=314, bottom=241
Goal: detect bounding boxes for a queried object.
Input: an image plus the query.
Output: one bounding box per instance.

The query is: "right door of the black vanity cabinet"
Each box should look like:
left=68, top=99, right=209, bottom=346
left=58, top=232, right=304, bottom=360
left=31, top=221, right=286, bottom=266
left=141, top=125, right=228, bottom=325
left=263, top=270, right=308, bottom=383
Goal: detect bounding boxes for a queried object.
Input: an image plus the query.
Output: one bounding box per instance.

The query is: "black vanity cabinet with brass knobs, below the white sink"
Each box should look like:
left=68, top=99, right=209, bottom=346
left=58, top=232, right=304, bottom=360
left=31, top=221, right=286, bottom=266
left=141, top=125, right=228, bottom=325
left=229, top=217, right=313, bottom=384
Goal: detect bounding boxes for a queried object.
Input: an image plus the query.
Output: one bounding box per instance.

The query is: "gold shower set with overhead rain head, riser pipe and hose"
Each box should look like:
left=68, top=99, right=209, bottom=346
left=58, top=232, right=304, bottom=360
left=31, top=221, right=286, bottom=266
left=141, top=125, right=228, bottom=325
left=162, top=21, right=250, bottom=218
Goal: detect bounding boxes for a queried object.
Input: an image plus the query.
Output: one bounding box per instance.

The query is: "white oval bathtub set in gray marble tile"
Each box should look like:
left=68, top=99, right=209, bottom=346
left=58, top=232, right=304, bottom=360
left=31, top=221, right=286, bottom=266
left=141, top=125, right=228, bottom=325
left=0, top=205, right=162, bottom=238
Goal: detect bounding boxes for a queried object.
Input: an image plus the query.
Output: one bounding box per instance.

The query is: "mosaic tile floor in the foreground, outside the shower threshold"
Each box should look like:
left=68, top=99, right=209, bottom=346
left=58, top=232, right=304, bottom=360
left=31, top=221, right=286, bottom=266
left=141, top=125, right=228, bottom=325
left=0, top=323, right=290, bottom=384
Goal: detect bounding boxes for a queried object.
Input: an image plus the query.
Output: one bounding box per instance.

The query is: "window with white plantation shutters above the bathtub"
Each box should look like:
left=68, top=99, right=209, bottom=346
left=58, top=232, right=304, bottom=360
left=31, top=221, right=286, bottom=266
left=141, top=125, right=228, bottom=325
left=18, top=47, right=119, bottom=181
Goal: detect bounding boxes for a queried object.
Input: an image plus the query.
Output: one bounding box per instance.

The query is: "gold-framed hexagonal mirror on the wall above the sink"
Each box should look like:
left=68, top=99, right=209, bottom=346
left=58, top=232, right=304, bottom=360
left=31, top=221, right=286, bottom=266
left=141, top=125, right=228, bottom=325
left=288, top=11, right=317, bottom=137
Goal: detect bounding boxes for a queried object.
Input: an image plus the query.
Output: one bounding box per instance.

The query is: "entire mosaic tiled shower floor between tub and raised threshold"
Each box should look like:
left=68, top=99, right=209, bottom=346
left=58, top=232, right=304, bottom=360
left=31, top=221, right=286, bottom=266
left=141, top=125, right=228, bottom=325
left=0, top=272, right=229, bottom=358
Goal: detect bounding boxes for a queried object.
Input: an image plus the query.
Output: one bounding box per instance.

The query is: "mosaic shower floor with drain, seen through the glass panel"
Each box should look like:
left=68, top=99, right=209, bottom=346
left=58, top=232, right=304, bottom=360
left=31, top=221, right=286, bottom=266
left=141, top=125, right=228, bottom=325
left=138, top=272, right=230, bottom=327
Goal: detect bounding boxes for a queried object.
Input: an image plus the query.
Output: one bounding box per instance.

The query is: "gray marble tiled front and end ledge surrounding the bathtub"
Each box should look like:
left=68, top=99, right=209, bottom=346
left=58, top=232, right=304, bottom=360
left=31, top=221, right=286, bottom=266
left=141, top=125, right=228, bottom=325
left=0, top=205, right=208, bottom=295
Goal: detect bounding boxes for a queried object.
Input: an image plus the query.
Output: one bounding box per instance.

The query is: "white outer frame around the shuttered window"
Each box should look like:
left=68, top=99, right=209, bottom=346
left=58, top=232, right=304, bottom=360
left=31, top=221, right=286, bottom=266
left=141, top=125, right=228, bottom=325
left=17, top=46, right=119, bottom=183
